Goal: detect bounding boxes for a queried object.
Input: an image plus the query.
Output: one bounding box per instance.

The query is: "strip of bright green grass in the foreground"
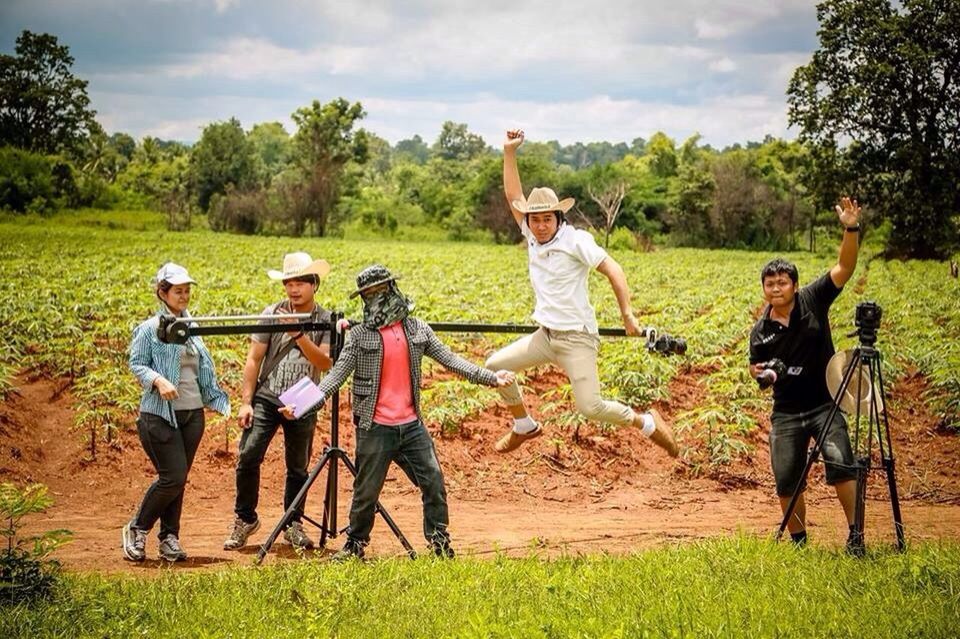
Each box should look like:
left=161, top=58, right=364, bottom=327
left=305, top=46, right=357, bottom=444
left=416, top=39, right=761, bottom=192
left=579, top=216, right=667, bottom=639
left=0, top=536, right=960, bottom=638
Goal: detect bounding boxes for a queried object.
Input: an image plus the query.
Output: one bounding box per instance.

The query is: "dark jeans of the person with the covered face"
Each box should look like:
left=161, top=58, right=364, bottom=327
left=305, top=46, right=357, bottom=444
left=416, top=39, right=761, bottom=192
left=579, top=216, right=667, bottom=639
left=348, top=421, right=450, bottom=545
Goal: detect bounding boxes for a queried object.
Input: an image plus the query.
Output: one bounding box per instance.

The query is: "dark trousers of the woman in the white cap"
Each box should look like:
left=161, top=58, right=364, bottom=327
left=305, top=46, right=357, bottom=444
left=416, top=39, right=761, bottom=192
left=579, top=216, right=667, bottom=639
left=133, top=408, right=205, bottom=540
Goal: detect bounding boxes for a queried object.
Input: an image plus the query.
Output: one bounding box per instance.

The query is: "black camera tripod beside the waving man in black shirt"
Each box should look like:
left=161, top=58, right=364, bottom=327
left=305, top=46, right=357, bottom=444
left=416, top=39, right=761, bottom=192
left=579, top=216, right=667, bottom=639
left=776, top=327, right=906, bottom=551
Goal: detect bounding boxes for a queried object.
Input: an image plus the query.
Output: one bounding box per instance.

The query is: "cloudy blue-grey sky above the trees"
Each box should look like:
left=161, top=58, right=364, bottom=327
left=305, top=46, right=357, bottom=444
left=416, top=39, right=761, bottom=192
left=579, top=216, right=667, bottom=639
left=0, top=0, right=817, bottom=146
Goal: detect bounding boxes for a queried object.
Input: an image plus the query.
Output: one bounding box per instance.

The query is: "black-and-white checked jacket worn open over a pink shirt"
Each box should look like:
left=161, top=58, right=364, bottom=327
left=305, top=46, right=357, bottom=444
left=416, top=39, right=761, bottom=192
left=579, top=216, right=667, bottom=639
left=318, top=317, right=497, bottom=430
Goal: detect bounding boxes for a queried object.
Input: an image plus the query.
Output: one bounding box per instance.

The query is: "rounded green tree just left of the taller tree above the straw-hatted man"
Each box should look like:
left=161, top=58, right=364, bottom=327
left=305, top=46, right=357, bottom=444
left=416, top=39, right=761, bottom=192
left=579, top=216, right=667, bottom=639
left=188, top=118, right=257, bottom=211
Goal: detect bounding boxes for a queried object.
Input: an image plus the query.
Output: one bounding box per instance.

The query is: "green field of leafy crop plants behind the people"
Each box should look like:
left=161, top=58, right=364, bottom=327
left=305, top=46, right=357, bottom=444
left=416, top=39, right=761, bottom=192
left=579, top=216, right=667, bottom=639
left=0, top=212, right=960, bottom=468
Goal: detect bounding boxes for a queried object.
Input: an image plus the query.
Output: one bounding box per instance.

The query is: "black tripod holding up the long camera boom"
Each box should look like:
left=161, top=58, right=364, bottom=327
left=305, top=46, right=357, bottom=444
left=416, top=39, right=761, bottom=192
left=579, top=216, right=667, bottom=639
left=256, top=312, right=417, bottom=564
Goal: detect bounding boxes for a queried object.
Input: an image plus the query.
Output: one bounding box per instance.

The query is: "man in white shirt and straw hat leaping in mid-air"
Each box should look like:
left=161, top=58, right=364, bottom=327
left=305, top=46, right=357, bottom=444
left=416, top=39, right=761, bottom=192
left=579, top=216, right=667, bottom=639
left=486, top=130, right=678, bottom=457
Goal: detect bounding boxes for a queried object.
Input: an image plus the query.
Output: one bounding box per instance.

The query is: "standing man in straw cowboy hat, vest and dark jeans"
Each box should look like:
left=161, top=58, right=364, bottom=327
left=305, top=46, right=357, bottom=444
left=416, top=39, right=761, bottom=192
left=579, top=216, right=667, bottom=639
left=223, top=253, right=333, bottom=550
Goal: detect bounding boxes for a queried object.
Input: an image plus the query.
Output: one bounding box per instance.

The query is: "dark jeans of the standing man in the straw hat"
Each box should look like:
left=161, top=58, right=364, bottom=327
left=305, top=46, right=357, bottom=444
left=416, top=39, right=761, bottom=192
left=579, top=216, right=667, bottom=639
left=234, top=400, right=317, bottom=524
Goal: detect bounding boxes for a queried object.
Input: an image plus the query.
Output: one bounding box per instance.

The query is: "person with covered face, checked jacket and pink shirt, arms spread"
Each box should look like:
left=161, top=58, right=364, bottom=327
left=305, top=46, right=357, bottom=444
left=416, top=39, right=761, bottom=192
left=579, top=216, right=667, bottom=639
left=281, top=264, right=514, bottom=560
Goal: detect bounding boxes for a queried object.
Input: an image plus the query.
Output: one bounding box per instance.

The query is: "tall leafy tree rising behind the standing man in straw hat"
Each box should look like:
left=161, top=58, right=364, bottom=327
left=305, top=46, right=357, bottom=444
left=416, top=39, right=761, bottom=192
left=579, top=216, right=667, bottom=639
left=291, top=98, right=368, bottom=236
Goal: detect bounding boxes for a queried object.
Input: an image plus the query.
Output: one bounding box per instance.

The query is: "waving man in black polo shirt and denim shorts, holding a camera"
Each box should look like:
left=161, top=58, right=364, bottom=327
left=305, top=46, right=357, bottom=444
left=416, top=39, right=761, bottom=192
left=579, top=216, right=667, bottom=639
left=750, top=198, right=863, bottom=552
